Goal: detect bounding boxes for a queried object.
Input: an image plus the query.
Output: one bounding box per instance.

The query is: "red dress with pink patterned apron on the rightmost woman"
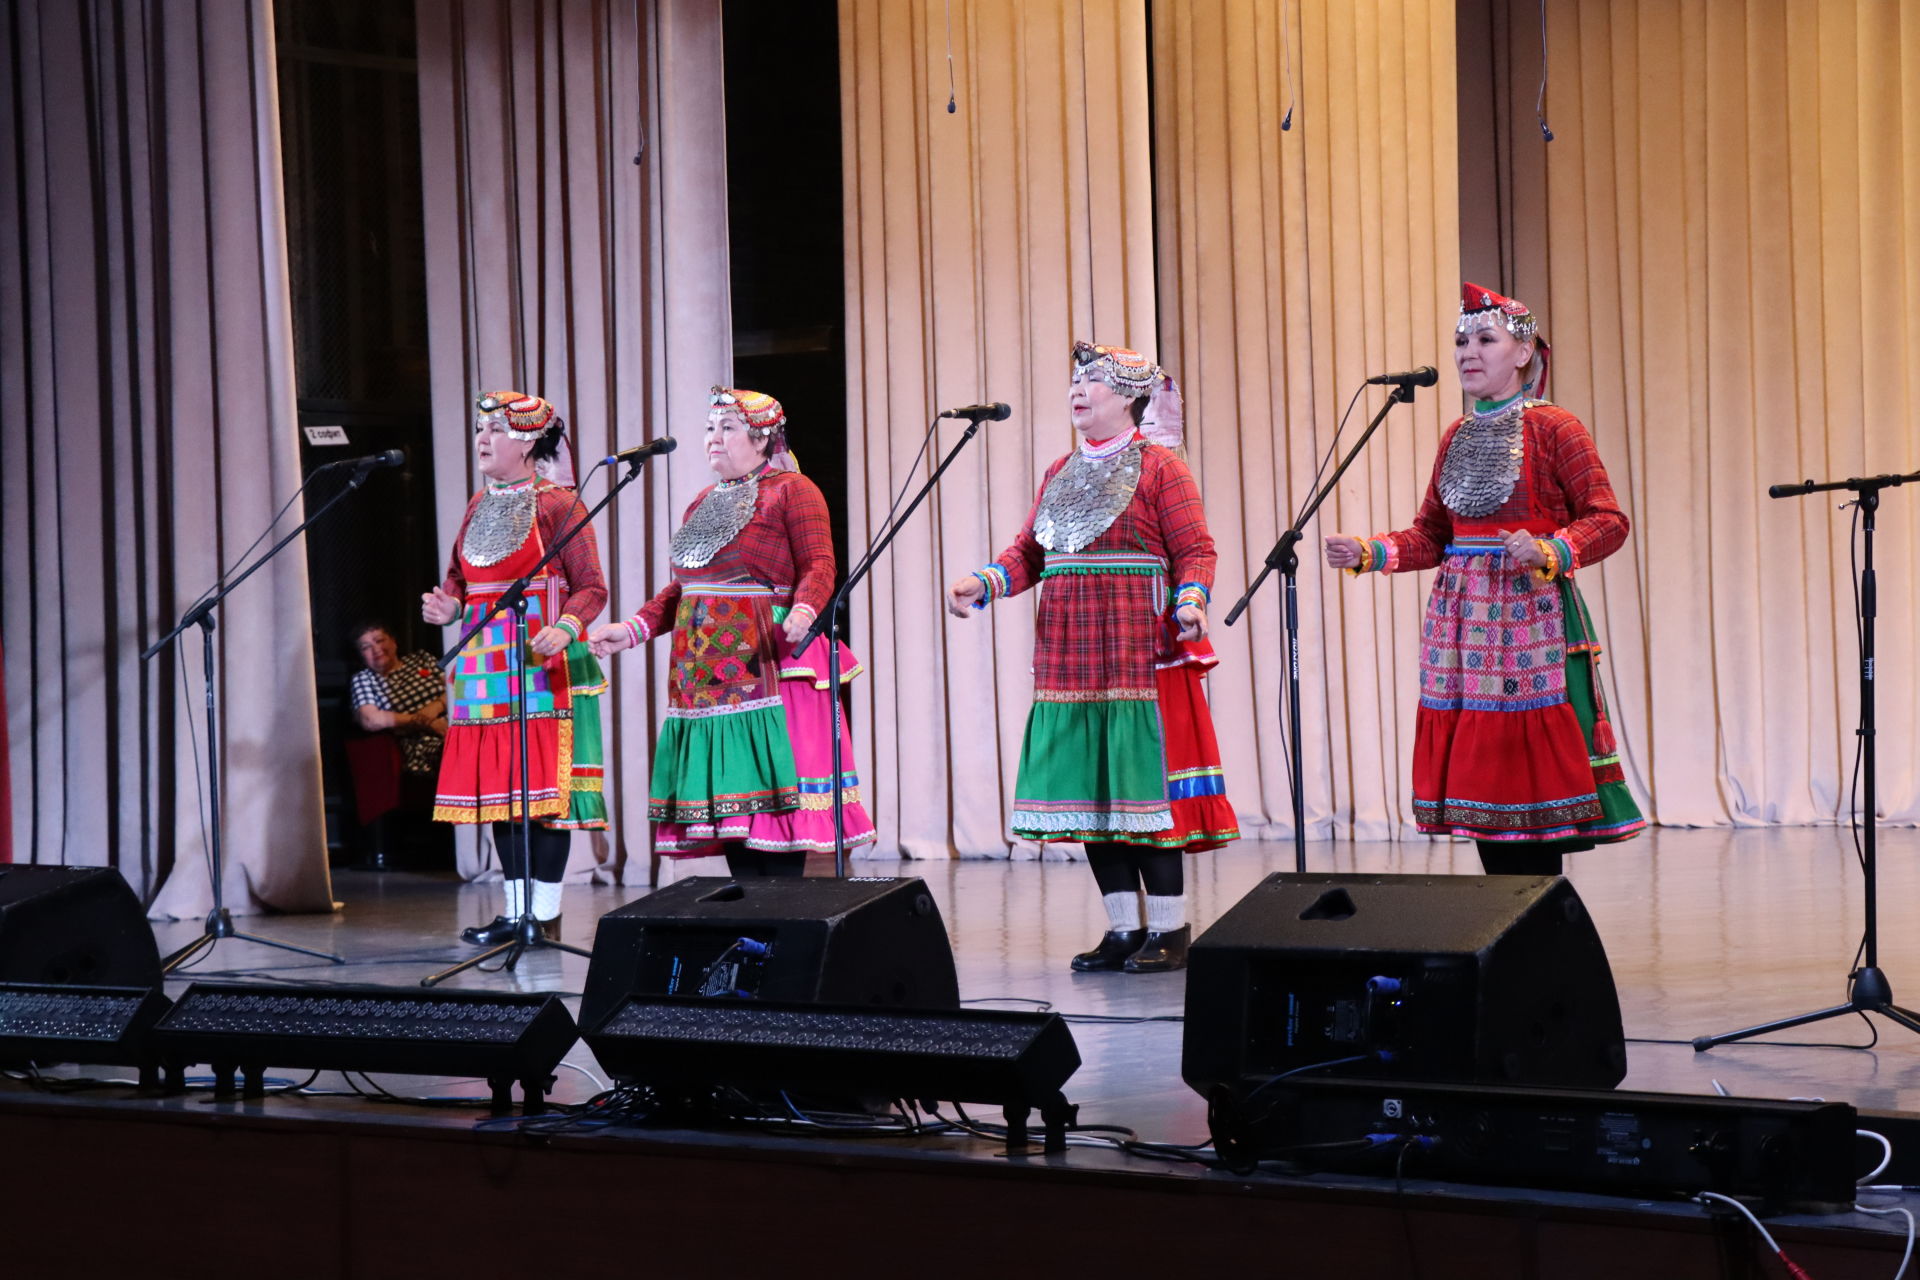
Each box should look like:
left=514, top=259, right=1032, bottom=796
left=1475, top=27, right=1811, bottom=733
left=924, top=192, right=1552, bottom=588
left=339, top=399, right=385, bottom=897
left=1373, top=401, right=1645, bottom=842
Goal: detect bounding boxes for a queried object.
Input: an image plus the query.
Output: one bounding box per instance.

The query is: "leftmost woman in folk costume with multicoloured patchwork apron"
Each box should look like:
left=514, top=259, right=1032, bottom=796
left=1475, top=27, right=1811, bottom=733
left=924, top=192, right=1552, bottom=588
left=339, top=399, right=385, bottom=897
left=420, top=391, right=607, bottom=946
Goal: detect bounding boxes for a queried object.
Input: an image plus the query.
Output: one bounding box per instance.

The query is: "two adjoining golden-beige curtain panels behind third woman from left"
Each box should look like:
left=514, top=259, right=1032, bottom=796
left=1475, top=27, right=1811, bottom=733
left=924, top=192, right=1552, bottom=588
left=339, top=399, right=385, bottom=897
left=841, top=0, right=1457, bottom=856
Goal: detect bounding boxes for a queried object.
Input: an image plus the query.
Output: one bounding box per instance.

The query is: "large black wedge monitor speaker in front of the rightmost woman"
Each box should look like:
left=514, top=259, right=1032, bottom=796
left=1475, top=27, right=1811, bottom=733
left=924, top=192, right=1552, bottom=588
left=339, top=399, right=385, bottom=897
left=1181, top=871, right=1626, bottom=1094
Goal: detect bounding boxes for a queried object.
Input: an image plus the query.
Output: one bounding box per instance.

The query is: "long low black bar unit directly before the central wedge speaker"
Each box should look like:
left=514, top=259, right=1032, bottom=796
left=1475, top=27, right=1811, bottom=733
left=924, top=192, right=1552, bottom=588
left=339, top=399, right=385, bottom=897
left=586, top=996, right=1081, bottom=1153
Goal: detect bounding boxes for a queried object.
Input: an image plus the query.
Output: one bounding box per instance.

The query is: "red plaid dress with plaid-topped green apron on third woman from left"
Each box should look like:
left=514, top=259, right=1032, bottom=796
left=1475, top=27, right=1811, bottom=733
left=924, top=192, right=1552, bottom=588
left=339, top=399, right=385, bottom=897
left=987, top=445, right=1238, bottom=852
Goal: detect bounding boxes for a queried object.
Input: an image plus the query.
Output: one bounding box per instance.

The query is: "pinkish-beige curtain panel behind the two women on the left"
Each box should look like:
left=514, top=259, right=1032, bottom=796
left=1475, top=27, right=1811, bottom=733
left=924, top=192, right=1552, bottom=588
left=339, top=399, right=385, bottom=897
left=417, top=0, right=732, bottom=883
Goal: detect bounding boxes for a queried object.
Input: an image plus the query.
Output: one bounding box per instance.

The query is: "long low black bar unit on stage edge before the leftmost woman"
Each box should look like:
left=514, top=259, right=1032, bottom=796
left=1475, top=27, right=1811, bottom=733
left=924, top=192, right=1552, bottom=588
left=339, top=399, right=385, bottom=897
left=154, top=983, right=580, bottom=1115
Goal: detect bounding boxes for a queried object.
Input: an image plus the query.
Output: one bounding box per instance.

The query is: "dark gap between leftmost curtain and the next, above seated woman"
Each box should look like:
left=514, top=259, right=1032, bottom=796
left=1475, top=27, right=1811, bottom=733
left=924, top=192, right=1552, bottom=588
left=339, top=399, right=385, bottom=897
left=273, top=0, right=440, bottom=860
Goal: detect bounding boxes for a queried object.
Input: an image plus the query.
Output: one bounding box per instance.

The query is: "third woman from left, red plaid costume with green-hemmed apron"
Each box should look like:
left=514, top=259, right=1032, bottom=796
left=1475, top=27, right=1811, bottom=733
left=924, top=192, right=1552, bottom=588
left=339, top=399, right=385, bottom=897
left=947, top=342, right=1240, bottom=973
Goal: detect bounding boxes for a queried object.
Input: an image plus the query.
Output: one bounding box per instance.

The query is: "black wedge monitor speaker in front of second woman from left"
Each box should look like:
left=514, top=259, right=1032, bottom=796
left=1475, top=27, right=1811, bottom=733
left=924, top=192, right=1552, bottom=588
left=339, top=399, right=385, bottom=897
left=580, top=875, right=960, bottom=1031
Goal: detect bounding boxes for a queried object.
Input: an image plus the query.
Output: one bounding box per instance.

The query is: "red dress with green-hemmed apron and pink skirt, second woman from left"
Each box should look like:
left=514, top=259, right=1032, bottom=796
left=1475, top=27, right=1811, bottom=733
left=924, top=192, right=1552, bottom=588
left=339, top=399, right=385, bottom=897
left=628, top=472, right=874, bottom=858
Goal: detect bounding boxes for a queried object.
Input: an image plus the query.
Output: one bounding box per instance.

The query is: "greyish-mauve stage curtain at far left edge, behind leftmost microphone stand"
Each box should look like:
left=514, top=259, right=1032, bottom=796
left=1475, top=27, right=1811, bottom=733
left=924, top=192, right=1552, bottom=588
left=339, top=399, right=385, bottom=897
left=0, top=0, right=332, bottom=917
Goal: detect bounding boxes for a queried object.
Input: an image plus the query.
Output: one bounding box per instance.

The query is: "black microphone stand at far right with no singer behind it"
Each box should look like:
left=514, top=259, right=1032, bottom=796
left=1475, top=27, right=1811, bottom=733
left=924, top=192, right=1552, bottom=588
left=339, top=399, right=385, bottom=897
left=1693, top=472, right=1920, bottom=1054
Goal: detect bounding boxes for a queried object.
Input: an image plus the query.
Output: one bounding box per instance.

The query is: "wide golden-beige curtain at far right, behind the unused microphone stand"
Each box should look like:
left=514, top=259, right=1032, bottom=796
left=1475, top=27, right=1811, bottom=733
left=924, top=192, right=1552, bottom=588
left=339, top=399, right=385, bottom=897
left=1463, top=0, right=1920, bottom=825
